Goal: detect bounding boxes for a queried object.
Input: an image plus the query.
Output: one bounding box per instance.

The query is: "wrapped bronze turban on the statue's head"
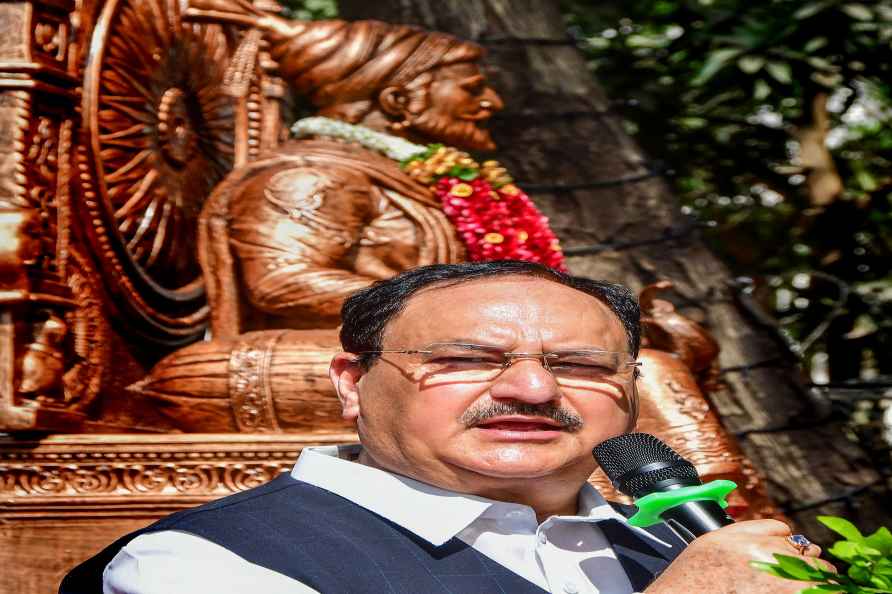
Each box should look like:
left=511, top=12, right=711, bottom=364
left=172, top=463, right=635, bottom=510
left=271, top=20, right=483, bottom=107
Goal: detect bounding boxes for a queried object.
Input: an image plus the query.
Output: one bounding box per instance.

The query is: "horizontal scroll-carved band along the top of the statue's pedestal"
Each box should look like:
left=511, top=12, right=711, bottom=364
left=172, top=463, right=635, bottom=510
left=0, top=433, right=356, bottom=504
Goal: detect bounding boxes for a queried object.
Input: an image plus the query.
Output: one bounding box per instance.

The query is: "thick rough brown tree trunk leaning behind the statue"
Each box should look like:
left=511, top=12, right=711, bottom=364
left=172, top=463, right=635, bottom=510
left=339, top=0, right=892, bottom=541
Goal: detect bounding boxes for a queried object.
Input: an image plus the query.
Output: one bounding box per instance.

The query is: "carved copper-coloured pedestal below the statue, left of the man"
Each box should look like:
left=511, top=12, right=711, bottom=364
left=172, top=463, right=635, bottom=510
left=0, top=433, right=357, bottom=594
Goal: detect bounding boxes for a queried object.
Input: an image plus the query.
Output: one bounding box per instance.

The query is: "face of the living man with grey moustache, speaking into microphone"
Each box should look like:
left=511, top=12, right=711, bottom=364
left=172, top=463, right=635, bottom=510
left=342, top=277, right=631, bottom=493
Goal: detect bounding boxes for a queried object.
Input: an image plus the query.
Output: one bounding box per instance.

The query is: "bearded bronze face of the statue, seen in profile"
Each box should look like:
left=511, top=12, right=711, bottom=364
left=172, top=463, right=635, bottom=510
left=411, top=62, right=503, bottom=151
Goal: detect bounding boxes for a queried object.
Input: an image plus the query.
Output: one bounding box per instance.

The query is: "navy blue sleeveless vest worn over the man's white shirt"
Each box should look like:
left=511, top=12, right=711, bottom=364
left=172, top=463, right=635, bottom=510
left=59, top=474, right=684, bottom=594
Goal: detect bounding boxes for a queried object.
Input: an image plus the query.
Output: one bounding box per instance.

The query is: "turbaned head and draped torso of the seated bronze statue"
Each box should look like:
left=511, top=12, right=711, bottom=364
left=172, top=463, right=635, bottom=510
left=192, top=8, right=501, bottom=336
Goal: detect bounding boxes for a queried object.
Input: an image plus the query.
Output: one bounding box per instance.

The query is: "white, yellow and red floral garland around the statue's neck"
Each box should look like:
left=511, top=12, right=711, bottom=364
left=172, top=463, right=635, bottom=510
left=291, top=117, right=566, bottom=271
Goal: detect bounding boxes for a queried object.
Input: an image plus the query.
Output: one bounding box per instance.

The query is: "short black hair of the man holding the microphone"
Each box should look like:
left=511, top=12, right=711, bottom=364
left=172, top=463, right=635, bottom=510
left=340, top=260, right=641, bottom=366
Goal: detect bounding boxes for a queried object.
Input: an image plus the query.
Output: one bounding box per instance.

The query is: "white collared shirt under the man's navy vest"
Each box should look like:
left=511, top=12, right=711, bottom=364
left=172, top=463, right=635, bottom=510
left=103, top=446, right=669, bottom=594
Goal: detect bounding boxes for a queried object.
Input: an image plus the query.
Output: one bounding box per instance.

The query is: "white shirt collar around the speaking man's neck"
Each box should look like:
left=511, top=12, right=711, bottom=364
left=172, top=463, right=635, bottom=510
left=291, top=444, right=669, bottom=546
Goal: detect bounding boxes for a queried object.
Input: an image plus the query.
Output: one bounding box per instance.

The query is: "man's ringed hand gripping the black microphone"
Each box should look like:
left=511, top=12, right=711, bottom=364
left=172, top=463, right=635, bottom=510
left=645, top=520, right=835, bottom=594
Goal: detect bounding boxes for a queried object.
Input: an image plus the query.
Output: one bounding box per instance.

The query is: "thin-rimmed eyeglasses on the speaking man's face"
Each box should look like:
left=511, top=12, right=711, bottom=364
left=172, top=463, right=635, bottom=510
left=357, top=342, right=640, bottom=385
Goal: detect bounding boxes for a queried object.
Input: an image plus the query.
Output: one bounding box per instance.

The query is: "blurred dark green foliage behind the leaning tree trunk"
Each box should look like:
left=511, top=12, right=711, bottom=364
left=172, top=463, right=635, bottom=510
left=283, top=0, right=892, bottom=490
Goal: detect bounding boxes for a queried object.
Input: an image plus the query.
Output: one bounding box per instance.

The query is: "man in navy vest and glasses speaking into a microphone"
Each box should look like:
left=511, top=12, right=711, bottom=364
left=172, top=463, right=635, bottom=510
left=61, top=261, right=820, bottom=594
